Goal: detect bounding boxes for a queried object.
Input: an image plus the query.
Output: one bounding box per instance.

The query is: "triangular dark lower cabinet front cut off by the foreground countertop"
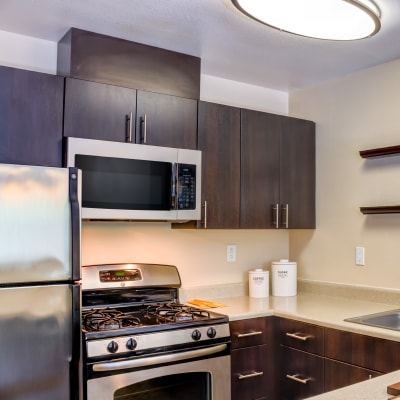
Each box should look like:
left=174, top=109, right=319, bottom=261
left=324, top=359, right=382, bottom=392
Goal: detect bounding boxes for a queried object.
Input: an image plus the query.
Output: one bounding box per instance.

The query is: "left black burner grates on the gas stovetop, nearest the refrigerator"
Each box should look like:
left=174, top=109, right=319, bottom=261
left=82, top=308, right=140, bottom=332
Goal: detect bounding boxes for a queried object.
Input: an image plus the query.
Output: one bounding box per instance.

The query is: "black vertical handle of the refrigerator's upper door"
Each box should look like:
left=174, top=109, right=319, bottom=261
left=69, top=167, right=81, bottom=281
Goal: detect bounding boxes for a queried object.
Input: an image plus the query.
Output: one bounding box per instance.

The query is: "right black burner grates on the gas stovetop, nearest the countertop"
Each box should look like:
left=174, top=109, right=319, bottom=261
left=145, top=302, right=210, bottom=323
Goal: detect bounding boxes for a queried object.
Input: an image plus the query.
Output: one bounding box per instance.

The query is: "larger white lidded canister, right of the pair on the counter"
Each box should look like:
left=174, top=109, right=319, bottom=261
left=271, top=260, right=297, bottom=296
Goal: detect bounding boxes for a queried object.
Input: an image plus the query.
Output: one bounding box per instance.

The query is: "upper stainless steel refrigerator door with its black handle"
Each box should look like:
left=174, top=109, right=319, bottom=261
left=0, top=164, right=80, bottom=285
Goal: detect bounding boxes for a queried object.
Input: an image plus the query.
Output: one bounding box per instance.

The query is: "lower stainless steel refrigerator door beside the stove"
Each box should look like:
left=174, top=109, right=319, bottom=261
left=0, top=285, right=81, bottom=400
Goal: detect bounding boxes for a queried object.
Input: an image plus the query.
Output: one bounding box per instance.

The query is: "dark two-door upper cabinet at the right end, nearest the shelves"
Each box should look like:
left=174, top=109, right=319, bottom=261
left=240, top=109, right=315, bottom=229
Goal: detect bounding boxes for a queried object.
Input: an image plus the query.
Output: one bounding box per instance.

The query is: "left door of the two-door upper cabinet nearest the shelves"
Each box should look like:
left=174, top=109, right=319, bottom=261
left=240, top=110, right=283, bottom=229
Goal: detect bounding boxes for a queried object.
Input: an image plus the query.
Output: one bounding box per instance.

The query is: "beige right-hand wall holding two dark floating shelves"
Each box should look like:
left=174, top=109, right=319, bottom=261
left=289, top=60, right=400, bottom=288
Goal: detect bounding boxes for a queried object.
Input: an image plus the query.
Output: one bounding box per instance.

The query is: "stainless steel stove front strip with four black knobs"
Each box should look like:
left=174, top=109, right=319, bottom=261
left=86, top=323, right=230, bottom=358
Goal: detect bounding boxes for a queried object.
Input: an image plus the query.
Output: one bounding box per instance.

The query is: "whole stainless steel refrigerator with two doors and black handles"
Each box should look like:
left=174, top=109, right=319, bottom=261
left=0, top=164, right=82, bottom=400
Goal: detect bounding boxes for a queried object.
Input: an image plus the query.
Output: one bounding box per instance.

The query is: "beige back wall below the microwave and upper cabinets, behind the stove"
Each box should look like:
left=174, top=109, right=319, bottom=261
left=82, top=222, right=289, bottom=287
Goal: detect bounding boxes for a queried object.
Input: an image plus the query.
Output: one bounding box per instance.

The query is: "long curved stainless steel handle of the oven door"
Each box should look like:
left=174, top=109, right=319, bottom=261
left=93, top=344, right=228, bottom=372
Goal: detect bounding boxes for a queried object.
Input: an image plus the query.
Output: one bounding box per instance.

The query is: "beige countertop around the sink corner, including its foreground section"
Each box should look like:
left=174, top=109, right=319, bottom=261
left=187, top=293, right=400, bottom=400
